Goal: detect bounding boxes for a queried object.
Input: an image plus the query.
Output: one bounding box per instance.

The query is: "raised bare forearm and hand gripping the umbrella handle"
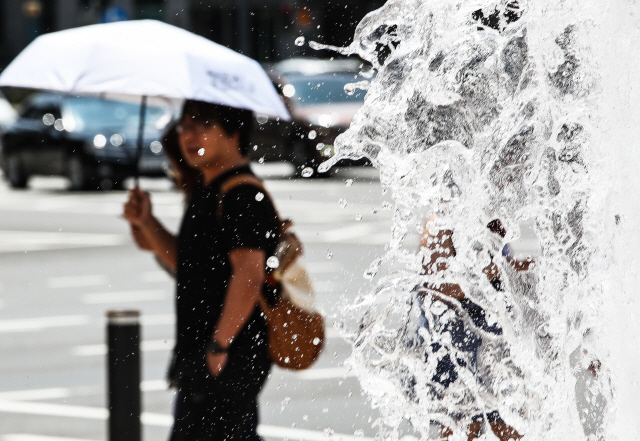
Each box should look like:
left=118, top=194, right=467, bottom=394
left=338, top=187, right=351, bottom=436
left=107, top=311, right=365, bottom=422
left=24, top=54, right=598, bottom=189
left=124, top=188, right=178, bottom=271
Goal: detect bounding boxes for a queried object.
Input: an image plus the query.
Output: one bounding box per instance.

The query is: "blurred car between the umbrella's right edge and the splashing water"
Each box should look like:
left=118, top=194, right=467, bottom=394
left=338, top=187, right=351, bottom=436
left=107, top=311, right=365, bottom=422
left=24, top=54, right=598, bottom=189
left=252, top=58, right=366, bottom=176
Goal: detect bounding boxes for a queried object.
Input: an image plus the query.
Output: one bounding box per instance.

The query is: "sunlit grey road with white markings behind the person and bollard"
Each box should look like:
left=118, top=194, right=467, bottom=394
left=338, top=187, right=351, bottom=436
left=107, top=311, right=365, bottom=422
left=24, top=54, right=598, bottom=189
left=0, top=165, right=544, bottom=441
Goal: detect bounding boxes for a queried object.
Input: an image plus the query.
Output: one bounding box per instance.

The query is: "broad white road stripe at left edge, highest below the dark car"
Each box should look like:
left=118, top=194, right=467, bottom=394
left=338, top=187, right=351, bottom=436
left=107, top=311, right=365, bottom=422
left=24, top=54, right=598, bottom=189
left=0, top=230, right=130, bottom=253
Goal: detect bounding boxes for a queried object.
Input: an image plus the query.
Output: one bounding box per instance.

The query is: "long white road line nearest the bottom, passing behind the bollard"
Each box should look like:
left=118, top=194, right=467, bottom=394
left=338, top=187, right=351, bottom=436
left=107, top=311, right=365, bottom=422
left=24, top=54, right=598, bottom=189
left=0, top=401, right=373, bottom=441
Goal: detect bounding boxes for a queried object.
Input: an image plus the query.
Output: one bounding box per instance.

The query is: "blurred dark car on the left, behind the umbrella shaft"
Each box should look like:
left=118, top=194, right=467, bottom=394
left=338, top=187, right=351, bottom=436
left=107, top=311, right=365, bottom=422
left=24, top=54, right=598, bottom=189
left=0, top=93, right=173, bottom=190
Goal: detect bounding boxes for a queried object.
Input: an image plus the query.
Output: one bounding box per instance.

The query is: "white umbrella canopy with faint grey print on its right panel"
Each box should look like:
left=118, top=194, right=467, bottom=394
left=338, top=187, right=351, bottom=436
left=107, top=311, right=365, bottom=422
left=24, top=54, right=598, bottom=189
left=0, top=20, right=290, bottom=120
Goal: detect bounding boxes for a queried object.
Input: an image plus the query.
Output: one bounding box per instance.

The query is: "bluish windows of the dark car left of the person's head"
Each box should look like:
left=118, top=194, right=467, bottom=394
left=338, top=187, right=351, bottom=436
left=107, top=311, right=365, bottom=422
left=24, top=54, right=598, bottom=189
left=66, top=97, right=172, bottom=135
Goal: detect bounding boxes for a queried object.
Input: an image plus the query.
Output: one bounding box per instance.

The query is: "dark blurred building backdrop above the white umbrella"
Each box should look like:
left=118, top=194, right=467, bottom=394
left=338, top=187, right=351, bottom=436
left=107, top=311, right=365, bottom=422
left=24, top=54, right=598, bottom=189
left=0, top=0, right=384, bottom=67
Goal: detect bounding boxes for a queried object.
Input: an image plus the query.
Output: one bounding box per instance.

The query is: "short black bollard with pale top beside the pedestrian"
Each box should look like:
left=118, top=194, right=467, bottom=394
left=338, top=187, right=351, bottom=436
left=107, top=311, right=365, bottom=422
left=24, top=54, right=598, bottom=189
left=107, top=311, right=142, bottom=441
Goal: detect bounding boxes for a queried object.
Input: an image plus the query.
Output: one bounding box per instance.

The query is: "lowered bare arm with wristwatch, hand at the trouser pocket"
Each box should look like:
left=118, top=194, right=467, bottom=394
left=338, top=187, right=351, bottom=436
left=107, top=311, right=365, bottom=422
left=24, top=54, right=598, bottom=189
left=207, top=248, right=266, bottom=375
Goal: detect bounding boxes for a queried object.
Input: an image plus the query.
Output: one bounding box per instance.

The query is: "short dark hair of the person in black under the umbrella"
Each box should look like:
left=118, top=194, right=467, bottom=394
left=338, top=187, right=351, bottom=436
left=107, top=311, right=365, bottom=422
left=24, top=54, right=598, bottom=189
left=182, top=100, right=253, bottom=156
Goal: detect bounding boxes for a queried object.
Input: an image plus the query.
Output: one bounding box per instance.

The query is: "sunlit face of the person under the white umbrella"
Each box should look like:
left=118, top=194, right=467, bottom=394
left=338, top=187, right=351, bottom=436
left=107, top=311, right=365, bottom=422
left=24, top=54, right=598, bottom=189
left=177, top=115, right=238, bottom=171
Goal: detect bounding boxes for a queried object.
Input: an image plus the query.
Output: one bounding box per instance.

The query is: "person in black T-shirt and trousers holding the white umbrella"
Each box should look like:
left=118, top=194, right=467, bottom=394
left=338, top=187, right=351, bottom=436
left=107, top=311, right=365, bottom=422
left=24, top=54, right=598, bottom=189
left=124, top=100, right=279, bottom=441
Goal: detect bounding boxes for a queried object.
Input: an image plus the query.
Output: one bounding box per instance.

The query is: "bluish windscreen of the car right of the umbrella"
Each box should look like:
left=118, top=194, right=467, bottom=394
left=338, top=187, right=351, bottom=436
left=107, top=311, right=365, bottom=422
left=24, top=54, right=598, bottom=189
left=282, top=74, right=366, bottom=106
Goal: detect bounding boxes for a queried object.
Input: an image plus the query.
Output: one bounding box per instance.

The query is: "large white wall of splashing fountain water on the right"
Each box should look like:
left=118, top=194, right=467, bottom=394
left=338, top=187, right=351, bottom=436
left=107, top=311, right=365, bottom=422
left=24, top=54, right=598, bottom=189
left=316, top=0, right=640, bottom=441
